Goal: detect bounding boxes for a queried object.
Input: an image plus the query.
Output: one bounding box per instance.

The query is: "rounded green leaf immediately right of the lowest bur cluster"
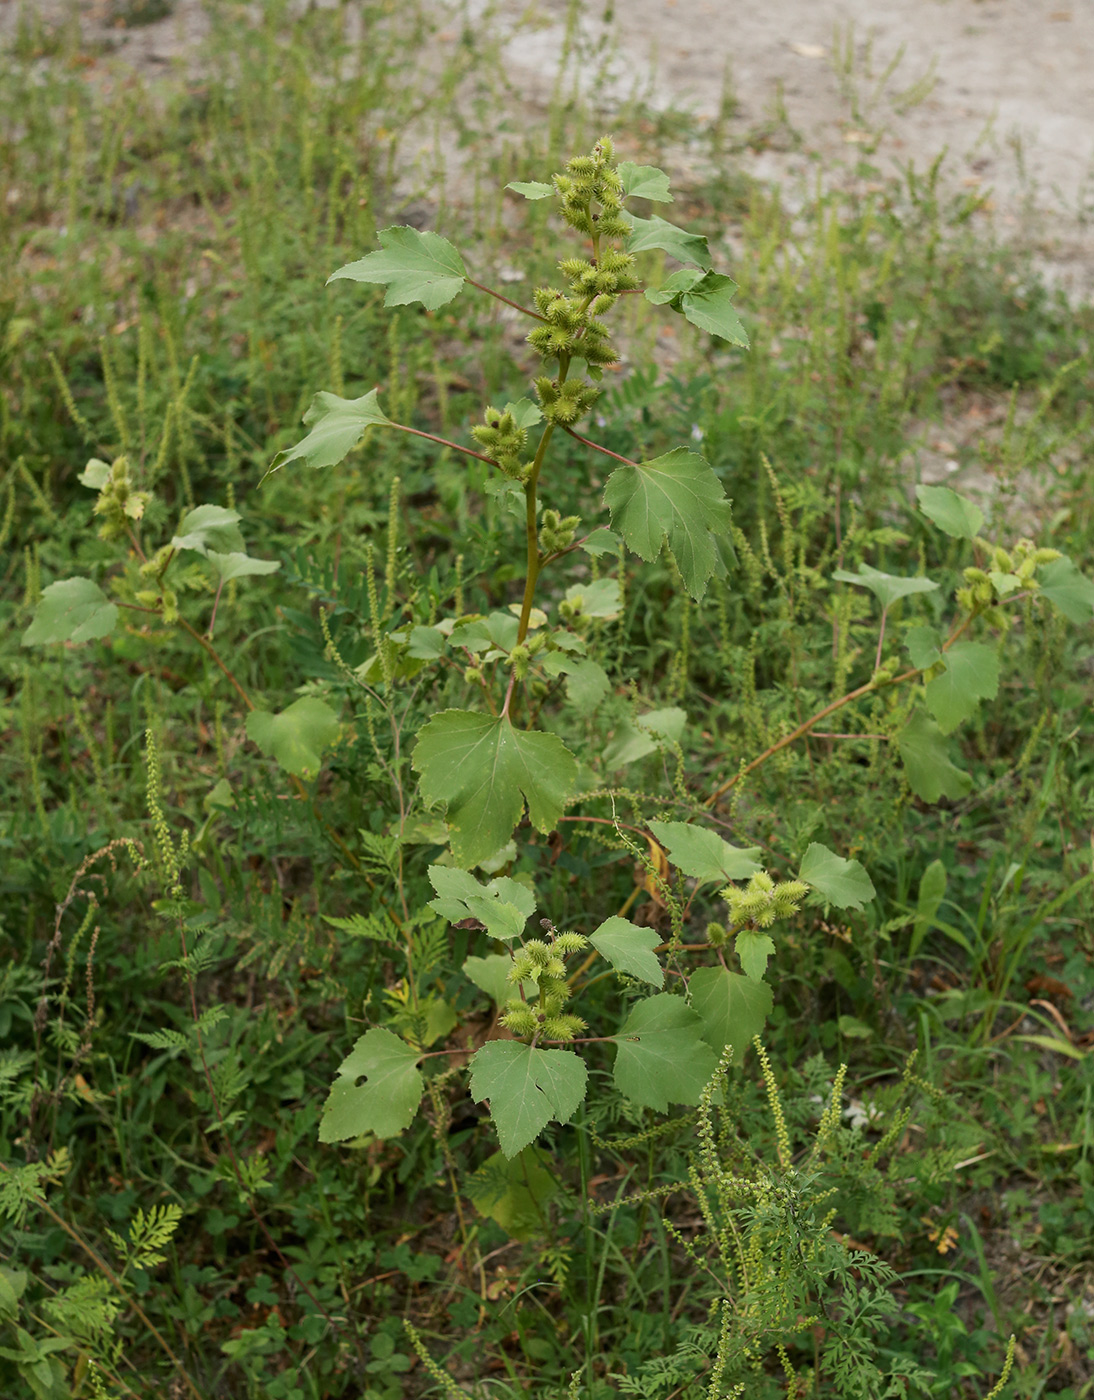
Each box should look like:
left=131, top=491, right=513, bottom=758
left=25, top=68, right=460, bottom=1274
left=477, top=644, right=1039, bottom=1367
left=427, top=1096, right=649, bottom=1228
left=612, top=993, right=717, bottom=1113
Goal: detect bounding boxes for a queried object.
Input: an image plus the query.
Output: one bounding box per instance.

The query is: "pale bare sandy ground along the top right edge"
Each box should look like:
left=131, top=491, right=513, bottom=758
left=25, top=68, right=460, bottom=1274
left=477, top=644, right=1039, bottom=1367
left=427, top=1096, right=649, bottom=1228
left=0, top=0, right=1094, bottom=300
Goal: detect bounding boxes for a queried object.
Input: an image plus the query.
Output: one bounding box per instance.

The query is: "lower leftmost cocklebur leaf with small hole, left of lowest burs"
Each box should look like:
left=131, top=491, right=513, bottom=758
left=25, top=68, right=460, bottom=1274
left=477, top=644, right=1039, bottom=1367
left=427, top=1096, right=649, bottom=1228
left=319, top=1028, right=426, bottom=1142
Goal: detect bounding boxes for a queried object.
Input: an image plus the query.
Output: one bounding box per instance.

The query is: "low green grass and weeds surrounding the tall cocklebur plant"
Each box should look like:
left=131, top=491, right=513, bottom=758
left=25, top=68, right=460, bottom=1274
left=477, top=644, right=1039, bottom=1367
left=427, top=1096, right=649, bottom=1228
left=0, top=3, right=1094, bottom=1400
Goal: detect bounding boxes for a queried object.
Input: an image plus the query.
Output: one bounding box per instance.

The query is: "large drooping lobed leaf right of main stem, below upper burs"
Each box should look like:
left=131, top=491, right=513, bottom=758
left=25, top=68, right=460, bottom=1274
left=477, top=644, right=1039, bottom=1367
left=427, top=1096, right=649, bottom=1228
left=604, top=447, right=730, bottom=601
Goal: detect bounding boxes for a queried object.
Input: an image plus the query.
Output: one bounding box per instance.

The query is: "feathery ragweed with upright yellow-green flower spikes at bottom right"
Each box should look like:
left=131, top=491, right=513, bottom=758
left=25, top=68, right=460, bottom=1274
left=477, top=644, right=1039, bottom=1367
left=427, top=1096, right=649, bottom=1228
left=604, top=1039, right=1014, bottom=1400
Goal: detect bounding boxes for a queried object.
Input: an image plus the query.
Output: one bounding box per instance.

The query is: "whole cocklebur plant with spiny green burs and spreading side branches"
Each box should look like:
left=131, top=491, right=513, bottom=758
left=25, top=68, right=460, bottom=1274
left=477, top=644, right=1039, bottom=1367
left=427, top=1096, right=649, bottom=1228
left=24, top=139, right=1094, bottom=1176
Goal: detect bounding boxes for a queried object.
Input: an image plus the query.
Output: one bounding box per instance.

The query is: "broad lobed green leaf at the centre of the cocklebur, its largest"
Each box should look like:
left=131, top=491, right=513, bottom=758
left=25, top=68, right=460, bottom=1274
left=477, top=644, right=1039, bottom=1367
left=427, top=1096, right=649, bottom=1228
left=412, top=710, right=577, bottom=865
